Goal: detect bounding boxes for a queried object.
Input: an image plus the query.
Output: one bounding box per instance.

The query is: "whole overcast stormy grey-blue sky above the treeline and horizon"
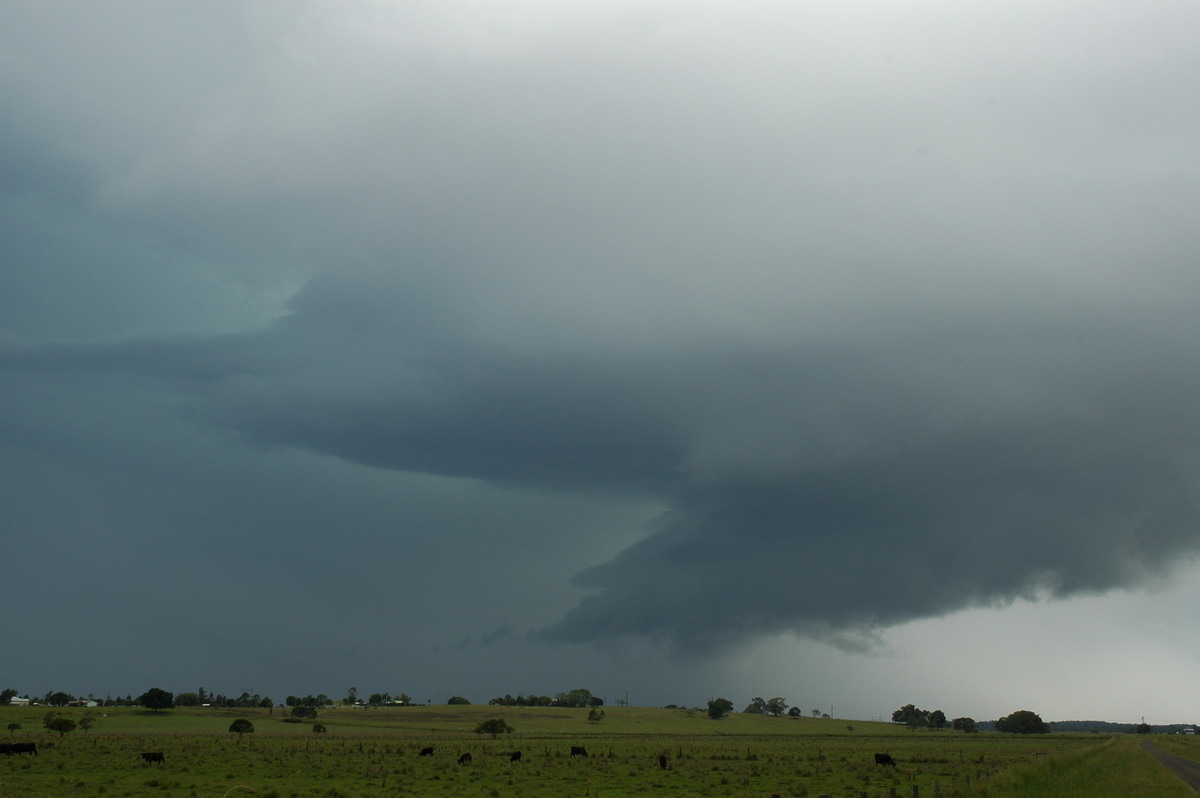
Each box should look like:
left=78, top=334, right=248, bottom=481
left=0, top=0, right=1200, bottom=722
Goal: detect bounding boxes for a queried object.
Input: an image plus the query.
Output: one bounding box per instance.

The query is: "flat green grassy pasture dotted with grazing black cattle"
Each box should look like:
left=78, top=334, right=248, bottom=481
left=0, top=706, right=1195, bottom=798
